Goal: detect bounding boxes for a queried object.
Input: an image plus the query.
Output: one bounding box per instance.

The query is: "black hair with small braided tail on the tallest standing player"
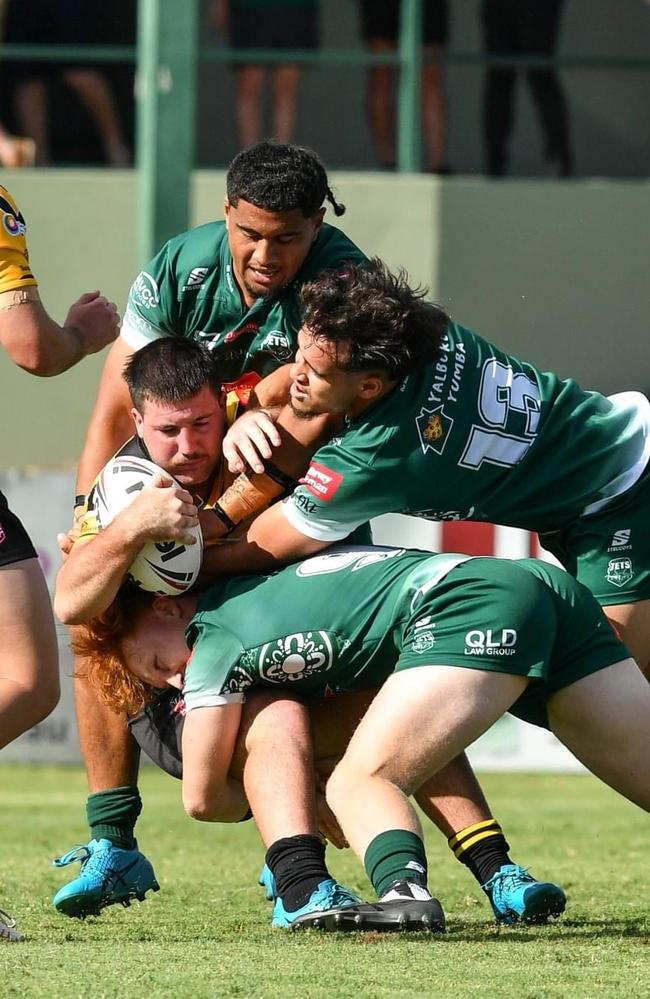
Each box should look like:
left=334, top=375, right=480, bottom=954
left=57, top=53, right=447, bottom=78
left=226, top=140, right=345, bottom=218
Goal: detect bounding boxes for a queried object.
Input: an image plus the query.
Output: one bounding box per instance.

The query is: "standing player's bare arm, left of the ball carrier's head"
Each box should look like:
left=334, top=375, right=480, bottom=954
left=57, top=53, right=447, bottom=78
left=76, top=337, right=133, bottom=494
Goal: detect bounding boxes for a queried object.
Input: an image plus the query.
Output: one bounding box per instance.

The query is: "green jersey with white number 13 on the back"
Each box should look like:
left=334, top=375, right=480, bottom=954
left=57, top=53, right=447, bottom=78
left=283, top=324, right=650, bottom=541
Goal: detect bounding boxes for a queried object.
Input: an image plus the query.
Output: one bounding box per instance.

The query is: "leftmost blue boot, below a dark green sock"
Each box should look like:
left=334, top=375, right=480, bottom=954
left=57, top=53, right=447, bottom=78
left=53, top=839, right=160, bottom=919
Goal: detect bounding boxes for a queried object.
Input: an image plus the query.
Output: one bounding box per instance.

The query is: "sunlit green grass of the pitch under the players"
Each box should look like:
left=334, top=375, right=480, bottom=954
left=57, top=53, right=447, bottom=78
left=0, top=764, right=650, bottom=999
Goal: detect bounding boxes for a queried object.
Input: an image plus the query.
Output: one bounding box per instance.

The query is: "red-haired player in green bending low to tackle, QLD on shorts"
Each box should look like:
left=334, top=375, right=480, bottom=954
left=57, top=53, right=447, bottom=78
left=83, top=545, right=650, bottom=929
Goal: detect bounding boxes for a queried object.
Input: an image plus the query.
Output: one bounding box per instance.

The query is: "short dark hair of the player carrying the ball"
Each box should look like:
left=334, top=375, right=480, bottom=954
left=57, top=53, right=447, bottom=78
left=124, top=336, right=222, bottom=411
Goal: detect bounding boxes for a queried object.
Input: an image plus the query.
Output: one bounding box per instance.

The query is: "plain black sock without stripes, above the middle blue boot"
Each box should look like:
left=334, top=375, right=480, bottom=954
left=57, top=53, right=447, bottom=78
left=266, top=835, right=330, bottom=912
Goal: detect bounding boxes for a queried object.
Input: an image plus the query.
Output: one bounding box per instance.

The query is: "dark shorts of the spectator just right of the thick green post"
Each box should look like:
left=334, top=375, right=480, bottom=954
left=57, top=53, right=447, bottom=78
left=230, top=3, right=318, bottom=49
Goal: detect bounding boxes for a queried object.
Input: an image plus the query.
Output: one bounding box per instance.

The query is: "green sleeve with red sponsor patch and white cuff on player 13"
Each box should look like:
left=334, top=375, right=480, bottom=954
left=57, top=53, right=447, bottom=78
left=283, top=445, right=398, bottom=543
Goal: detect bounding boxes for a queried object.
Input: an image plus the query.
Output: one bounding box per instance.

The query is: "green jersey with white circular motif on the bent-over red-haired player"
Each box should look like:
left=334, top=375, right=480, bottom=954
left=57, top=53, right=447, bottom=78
left=183, top=546, right=467, bottom=711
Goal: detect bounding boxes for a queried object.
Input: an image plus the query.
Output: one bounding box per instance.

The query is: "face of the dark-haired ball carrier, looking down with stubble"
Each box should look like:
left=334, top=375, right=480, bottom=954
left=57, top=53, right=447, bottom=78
left=132, top=386, right=225, bottom=489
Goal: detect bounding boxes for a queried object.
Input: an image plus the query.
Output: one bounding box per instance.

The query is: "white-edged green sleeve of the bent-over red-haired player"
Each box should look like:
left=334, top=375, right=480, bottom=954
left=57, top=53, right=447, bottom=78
left=183, top=619, right=252, bottom=712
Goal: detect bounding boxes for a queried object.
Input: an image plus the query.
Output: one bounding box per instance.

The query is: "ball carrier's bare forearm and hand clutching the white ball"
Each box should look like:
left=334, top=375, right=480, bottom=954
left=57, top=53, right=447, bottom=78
left=54, top=475, right=198, bottom=624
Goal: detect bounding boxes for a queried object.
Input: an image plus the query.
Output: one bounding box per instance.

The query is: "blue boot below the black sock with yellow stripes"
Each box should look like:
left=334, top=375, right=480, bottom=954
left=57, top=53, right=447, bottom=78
left=482, top=864, right=566, bottom=924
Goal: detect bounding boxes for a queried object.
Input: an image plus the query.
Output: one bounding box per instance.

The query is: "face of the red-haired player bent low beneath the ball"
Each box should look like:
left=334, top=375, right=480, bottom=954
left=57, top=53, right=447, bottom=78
left=122, top=597, right=190, bottom=690
